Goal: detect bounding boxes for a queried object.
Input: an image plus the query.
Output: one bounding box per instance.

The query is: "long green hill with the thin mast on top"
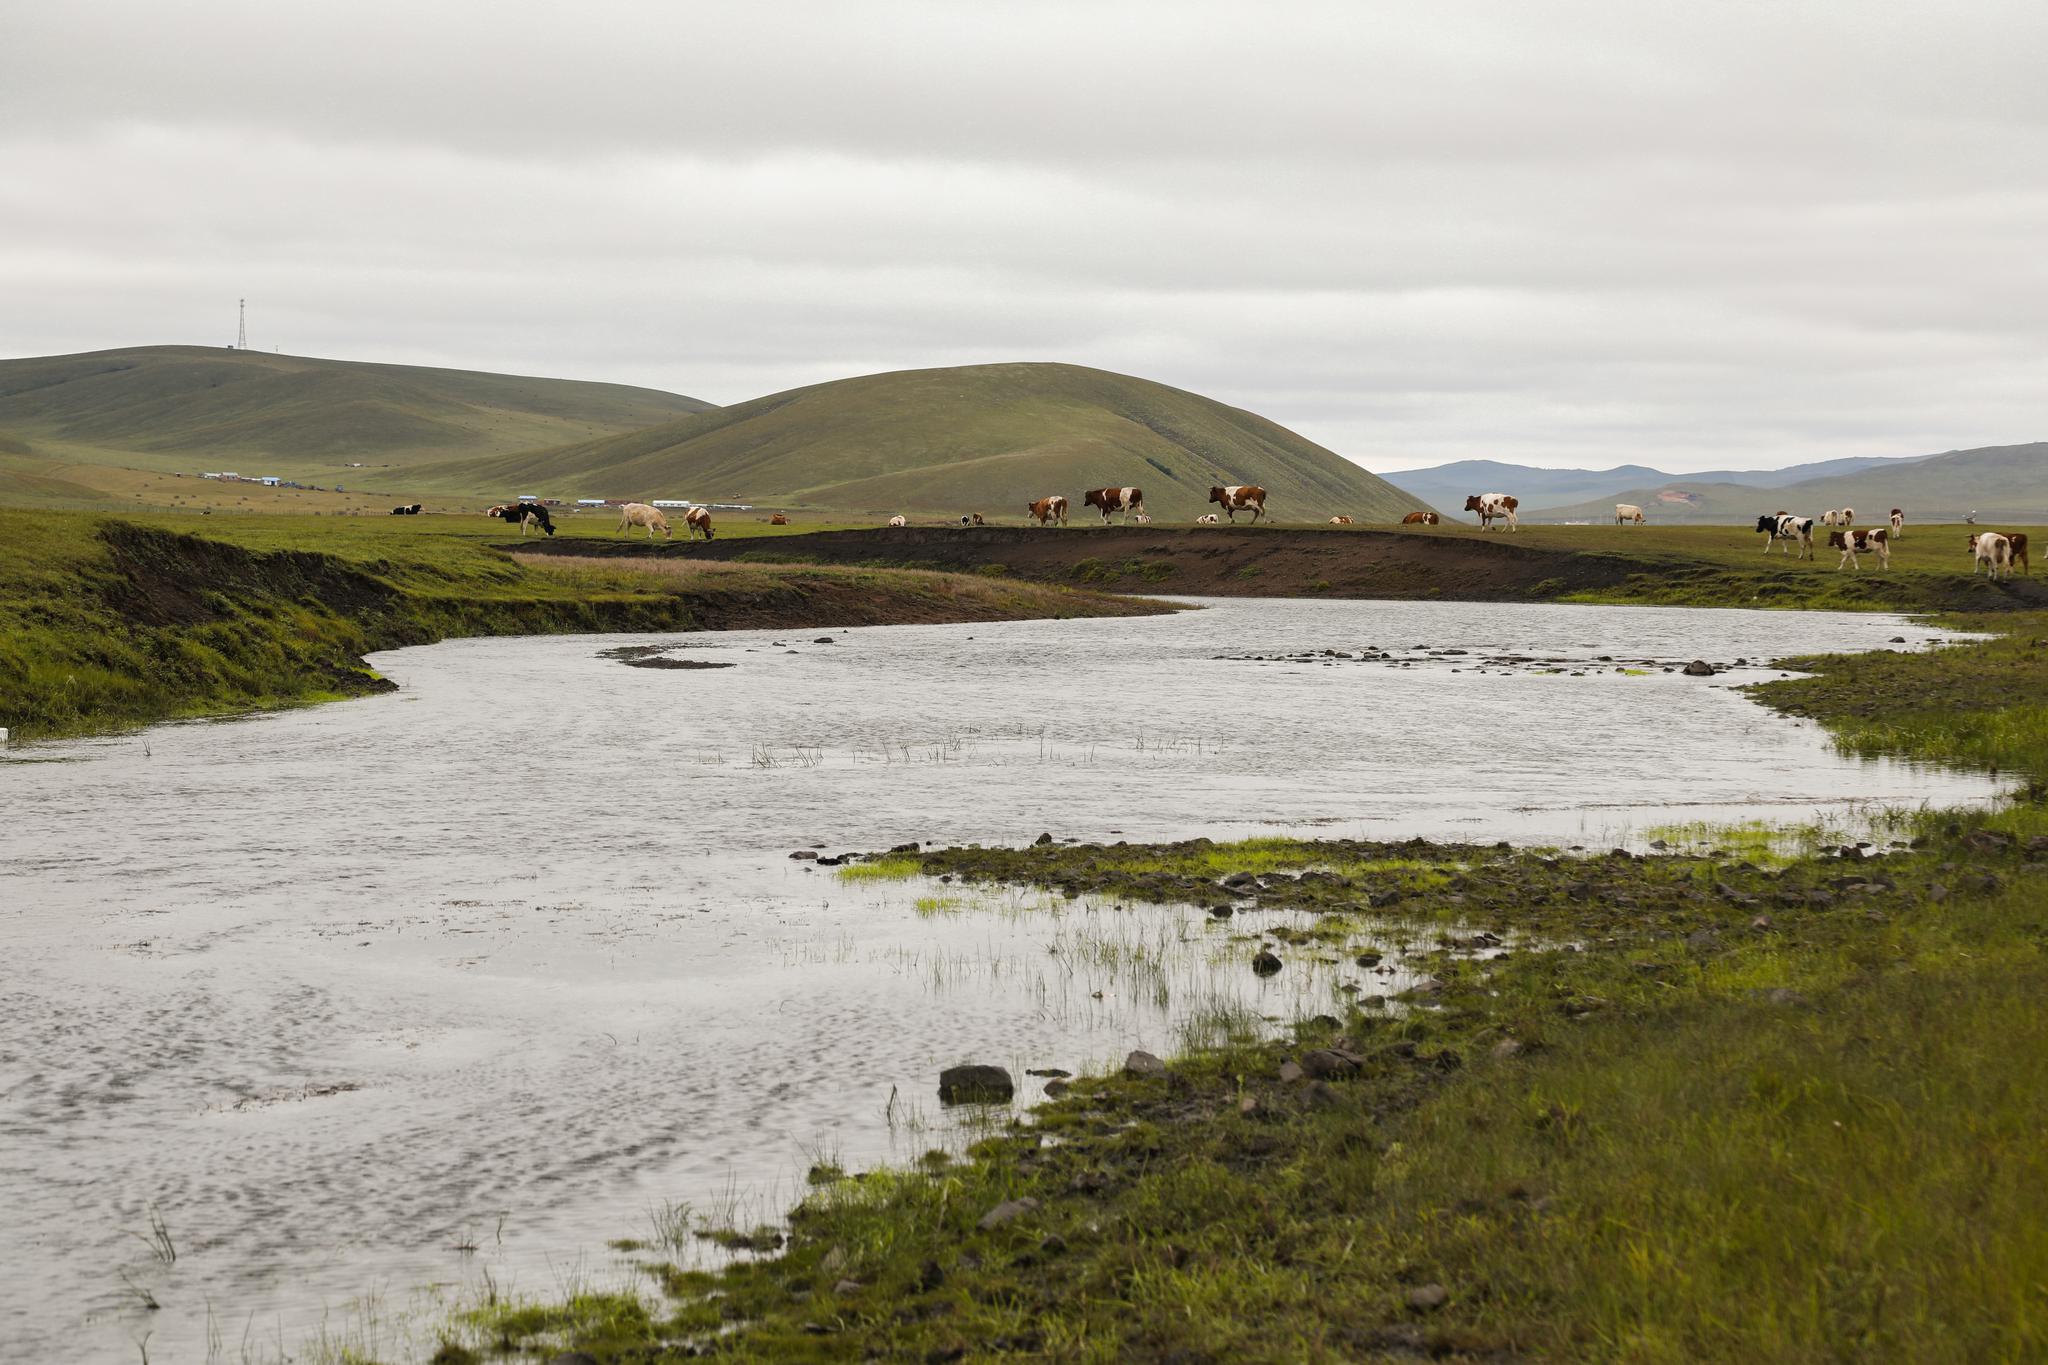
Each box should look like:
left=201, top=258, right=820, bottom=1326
left=0, top=346, right=711, bottom=477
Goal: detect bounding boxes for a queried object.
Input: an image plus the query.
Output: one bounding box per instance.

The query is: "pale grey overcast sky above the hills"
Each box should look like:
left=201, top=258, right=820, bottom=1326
left=0, top=0, right=2048, bottom=469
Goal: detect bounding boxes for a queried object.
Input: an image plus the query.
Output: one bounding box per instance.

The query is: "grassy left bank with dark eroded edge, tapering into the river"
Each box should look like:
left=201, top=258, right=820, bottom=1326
left=0, top=510, right=1163, bottom=739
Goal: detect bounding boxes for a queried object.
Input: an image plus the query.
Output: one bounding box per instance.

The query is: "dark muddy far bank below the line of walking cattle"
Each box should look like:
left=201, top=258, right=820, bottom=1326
left=503, top=526, right=2048, bottom=612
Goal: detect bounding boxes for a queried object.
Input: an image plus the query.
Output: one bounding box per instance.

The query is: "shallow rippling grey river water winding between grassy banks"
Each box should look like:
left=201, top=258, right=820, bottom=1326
left=0, top=600, right=1993, bottom=1361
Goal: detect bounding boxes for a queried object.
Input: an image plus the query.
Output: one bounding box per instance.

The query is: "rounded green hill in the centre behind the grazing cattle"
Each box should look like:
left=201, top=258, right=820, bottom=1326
left=446, top=364, right=1421, bottom=520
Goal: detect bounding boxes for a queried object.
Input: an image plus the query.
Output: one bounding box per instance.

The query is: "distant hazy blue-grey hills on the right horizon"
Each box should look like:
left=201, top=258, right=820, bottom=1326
left=1538, top=440, right=2048, bottom=526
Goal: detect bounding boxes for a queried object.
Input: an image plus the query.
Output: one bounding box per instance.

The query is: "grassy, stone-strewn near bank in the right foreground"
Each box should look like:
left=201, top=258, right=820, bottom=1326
left=436, top=614, right=2048, bottom=1365
